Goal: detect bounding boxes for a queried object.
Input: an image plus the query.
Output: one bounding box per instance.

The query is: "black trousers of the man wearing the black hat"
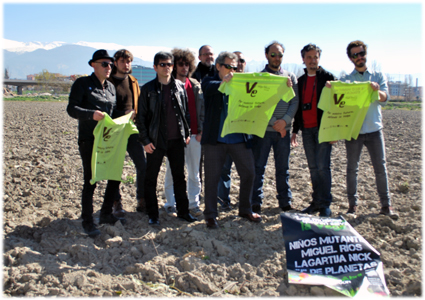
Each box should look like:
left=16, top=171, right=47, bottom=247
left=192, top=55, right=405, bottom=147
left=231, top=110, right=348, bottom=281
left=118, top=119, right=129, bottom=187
left=78, top=141, right=120, bottom=223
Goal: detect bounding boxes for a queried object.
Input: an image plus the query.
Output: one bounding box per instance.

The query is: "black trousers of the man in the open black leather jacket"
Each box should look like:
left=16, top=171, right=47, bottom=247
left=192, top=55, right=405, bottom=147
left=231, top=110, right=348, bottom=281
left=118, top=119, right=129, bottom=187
left=145, top=138, right=189, bottom=218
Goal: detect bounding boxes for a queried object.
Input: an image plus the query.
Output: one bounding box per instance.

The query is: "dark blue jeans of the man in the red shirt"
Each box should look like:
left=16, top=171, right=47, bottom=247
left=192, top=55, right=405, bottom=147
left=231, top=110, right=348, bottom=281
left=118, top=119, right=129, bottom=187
left=302, top=127, right=332, bottom=207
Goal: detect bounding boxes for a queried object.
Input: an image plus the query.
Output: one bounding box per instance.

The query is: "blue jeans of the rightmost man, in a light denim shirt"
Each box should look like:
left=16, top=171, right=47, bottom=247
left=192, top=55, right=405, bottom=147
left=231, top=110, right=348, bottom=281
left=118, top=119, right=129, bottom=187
left=345, top=130, right=391, bottom=207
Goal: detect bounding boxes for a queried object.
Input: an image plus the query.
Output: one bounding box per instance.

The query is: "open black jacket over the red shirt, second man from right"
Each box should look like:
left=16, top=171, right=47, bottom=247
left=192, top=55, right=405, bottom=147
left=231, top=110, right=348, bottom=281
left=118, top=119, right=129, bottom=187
left=292, top=67, right=338, bottom=133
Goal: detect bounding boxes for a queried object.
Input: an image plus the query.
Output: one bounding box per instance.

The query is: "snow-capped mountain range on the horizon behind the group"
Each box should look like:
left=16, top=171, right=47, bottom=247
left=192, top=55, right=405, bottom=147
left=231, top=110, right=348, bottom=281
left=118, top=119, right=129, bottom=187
left=3, top=38, right=302, bottom=79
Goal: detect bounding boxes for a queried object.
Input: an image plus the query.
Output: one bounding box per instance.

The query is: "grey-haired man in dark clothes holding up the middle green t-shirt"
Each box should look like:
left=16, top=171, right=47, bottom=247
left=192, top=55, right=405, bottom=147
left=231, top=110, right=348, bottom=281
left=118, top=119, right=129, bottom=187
left=201, top=52, right=261, bottom=229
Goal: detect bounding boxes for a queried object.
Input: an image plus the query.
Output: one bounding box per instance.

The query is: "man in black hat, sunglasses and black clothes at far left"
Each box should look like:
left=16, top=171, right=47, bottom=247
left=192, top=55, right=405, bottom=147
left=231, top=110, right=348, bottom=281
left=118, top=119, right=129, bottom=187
left=67, top=49, right=125, bottom=237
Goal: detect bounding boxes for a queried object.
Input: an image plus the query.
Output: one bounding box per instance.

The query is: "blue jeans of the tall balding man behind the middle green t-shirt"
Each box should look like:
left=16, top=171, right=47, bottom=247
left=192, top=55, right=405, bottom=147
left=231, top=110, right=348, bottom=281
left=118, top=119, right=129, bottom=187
left=251, top=131, right=292, bottom=208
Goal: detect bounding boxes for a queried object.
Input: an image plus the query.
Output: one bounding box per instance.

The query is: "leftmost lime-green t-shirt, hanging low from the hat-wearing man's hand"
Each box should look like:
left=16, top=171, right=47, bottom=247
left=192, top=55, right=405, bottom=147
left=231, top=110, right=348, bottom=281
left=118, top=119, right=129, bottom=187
left=90, top=113, right=138, bottom=184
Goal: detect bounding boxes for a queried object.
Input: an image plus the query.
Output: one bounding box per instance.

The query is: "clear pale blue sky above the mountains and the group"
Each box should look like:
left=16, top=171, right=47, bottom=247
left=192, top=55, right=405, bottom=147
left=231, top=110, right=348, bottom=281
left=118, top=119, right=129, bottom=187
left=3, top=2, right=423, bottom=84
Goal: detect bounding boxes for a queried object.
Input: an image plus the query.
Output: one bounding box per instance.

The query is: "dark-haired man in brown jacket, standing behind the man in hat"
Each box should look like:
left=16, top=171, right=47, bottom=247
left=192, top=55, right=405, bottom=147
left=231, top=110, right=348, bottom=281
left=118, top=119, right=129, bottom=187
left=108, top=49, right=146, bottom=217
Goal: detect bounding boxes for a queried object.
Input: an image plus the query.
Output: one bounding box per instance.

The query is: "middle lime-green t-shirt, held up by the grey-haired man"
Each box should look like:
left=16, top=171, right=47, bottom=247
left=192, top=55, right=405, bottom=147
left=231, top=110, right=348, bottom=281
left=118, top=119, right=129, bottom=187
left=218, top=72, right=295, bottom=138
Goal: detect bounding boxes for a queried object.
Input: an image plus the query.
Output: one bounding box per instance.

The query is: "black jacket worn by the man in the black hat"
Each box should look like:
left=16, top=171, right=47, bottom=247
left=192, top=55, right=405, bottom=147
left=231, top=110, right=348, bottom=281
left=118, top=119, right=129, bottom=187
left=66, top=73, right=124, bottom=142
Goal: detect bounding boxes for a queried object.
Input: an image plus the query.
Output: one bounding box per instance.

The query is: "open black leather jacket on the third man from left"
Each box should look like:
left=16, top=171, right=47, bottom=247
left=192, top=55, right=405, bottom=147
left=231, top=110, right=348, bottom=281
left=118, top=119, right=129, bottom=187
left=136, top=76, right=190, bottom=147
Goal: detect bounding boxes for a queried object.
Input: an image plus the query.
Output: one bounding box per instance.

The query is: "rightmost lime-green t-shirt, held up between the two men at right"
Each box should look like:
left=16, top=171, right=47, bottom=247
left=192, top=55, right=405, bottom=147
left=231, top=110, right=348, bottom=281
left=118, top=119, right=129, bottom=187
left=317, top=81, right=379, bottom=143
